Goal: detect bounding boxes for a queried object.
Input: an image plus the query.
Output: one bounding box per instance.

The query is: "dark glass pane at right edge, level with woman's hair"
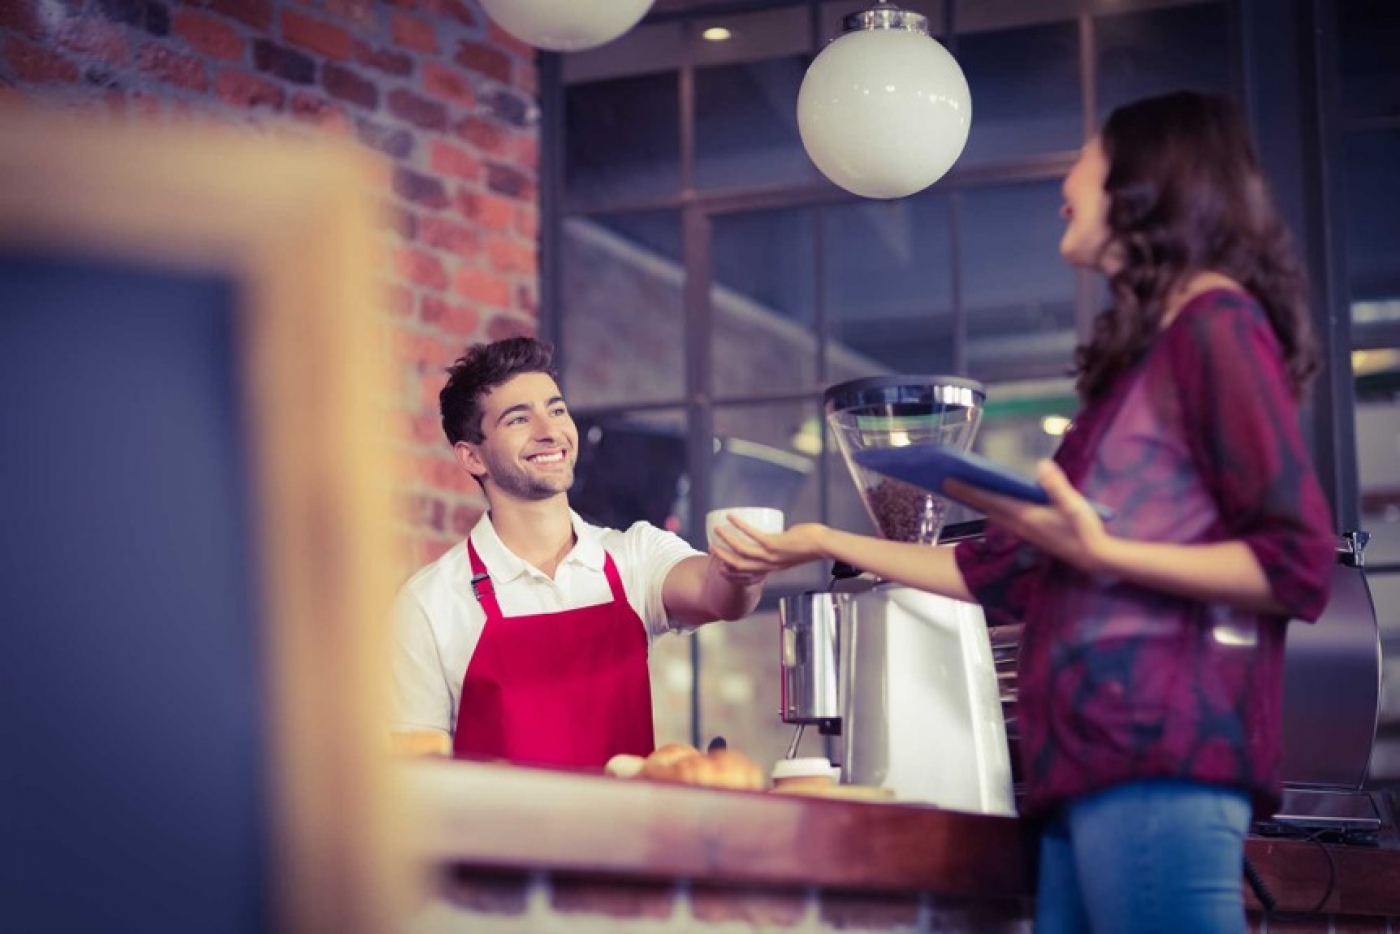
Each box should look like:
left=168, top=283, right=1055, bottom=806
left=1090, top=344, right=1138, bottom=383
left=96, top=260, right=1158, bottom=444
left=1345, top=129, right=1400, bottom=342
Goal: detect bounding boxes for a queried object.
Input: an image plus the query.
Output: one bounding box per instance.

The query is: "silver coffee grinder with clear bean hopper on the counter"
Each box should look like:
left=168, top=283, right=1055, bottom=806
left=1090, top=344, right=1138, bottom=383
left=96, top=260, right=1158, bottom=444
left=778, top=377, right=1015, bottom=815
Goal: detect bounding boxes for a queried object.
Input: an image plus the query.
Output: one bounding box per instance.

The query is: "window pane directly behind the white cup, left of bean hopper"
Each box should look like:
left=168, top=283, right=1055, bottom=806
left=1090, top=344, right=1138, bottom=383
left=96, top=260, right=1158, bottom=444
left=710, top=402, right=825, bottom=592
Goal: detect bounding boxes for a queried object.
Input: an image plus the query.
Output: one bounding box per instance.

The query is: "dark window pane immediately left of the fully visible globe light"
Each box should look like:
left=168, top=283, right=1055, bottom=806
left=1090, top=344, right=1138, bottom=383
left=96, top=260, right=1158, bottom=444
left=696, top=56, right=819, bottom=189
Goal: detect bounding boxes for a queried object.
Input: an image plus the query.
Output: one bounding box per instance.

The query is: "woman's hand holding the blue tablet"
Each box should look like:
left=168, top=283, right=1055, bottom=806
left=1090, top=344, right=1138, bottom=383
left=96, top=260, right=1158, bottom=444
left=948, top=461, right=1114, bottom=574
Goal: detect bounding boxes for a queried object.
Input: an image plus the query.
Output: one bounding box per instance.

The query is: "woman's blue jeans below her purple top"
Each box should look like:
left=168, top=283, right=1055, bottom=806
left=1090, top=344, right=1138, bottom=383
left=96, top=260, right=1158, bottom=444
left=1035, top=780, right=1250, bottom=934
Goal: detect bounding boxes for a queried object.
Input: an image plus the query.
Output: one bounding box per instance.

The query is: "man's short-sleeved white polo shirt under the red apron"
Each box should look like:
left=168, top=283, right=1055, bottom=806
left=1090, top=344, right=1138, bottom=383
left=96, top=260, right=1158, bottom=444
left=391, top=511, right=703, bottom=735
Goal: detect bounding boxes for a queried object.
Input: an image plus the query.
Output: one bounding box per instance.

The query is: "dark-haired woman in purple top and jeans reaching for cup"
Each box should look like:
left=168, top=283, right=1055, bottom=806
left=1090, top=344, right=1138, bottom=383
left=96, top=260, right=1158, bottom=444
left=715, top=92, right=1334, bottom=934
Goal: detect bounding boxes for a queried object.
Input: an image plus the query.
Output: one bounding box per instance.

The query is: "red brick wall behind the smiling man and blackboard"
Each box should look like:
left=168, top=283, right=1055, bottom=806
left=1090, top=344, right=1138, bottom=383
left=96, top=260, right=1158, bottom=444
left=0, top=0, right=539, bottom=576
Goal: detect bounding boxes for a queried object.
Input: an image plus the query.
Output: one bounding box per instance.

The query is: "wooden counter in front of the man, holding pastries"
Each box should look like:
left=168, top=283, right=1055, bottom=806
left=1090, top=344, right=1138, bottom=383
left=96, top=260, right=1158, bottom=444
left=399, top=762, right=1400, bottom=931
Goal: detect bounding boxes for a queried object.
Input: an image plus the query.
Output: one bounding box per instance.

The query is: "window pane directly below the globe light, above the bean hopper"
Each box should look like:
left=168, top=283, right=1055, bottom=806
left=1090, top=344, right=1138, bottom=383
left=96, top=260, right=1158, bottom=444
left=823, top=192, right=953, bottom=382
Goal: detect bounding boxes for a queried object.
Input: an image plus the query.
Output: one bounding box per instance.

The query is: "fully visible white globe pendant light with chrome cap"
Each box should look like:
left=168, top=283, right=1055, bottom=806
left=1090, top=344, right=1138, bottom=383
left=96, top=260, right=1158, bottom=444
left=797, top=0, right=972, bottom=197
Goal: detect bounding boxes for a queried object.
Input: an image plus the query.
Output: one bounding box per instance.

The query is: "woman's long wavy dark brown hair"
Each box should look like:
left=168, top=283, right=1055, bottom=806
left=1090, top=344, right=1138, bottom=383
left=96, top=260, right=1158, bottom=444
left=1074, top=91, right=1317, bottom=399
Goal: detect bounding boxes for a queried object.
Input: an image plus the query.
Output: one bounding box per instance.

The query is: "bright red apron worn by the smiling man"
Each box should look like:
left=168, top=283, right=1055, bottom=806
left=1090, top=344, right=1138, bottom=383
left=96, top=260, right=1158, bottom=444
left=452, top=541, right=655, bottom=769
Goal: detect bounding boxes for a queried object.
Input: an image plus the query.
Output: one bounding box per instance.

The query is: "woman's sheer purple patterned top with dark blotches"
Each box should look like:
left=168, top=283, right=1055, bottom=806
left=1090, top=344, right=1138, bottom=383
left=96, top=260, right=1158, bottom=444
left=956, top=290, right=1336, bottom=815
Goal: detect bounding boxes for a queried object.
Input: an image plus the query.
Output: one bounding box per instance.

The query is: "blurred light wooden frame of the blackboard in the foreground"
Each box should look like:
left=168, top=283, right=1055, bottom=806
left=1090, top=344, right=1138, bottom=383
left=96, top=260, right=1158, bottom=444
left=0, top=109, right=409, bottom=934
